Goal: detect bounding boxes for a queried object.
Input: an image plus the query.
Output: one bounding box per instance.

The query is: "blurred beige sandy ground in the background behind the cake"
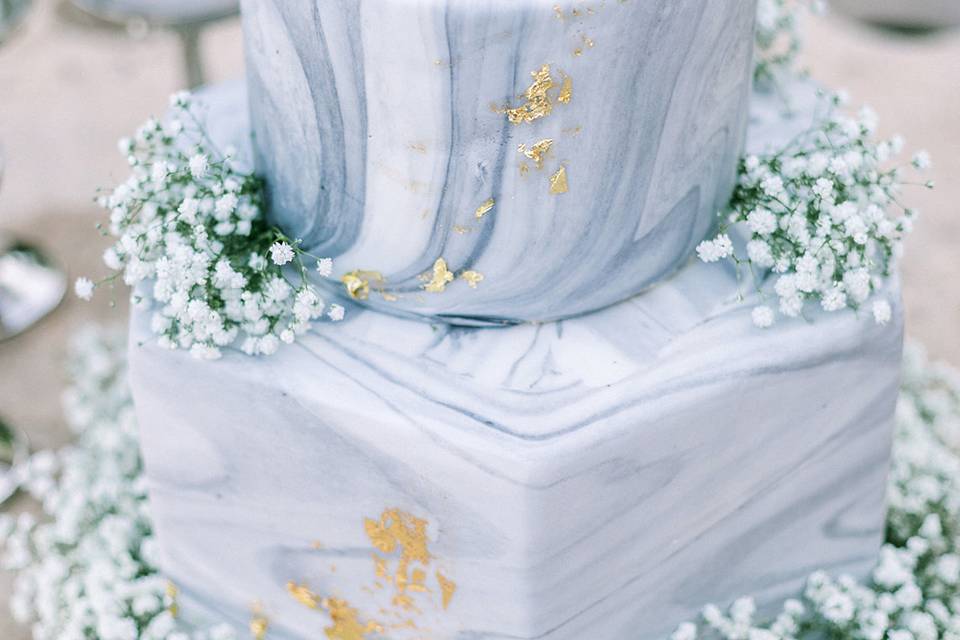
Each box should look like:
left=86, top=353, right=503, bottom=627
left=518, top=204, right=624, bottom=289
left=0, top=2, right=960, bottom=640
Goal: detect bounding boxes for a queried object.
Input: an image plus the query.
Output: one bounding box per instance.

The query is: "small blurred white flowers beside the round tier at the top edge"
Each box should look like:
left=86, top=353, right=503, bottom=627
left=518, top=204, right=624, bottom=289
left=754, top=0, right=826, bottom=86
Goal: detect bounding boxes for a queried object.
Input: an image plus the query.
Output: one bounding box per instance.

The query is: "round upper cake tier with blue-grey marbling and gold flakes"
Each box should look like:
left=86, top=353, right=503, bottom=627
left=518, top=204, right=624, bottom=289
left=243, top=0, right=755, bottom=324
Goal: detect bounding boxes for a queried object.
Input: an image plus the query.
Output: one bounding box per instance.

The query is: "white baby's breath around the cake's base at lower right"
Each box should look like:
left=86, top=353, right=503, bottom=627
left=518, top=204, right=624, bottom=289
left=672, top=348, right=960, bottom=640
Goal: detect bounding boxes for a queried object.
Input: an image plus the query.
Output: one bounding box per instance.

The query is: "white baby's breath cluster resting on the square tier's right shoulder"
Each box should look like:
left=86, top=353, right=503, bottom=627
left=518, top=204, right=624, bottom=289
left=697, top=96, right=932, bottom=327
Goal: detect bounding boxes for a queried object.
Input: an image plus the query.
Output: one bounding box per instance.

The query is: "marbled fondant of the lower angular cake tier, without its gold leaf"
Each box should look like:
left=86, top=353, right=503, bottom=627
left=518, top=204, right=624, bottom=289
left=130, top=81, right=902, bottom=640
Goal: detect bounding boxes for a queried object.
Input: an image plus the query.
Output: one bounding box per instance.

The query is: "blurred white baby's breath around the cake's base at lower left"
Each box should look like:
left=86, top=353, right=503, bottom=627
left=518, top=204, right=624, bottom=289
left=0, top=330, right=236, bottom=640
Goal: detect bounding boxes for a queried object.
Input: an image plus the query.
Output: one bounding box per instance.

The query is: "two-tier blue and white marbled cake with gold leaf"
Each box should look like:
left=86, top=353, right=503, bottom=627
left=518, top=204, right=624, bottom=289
left=130, top=0, right=901, bottom=640
